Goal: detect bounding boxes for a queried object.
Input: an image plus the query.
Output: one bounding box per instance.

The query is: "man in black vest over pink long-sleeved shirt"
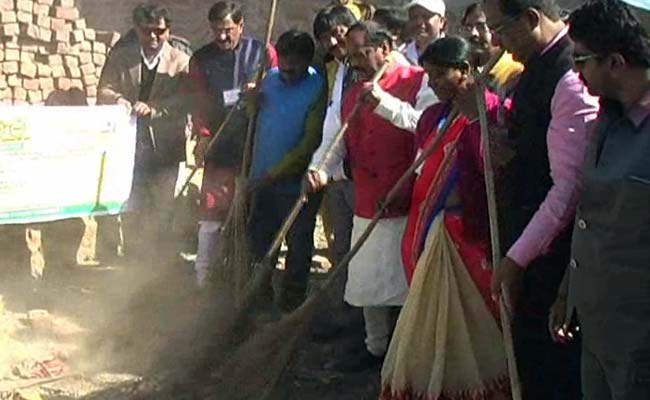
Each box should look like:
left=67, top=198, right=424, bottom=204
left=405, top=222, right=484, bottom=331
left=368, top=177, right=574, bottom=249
left=484, top=0, right=598, bottom=400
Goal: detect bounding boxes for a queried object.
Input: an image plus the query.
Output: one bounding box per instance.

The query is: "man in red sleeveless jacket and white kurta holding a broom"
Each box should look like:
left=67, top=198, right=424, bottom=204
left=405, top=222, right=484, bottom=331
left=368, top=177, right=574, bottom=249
left=307, top=22, right=436, bottom=369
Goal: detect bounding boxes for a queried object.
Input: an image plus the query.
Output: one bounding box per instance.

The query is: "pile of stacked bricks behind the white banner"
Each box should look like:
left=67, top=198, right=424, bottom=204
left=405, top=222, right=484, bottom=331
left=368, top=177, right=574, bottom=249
left=0, top=0, right=119, bottom=104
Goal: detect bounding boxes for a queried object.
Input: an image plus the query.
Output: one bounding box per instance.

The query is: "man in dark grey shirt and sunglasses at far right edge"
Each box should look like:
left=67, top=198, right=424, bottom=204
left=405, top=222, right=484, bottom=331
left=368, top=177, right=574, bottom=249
left=551, top=0, right=650, bottom=400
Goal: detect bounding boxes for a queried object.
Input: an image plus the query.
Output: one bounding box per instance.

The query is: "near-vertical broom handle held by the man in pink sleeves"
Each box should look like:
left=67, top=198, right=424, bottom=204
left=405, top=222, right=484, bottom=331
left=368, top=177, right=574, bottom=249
left=476, top=72, right=521, bottom=400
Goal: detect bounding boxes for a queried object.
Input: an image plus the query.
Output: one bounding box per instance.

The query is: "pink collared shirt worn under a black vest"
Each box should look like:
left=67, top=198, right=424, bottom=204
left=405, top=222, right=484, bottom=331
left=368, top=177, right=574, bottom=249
left=508, top=28, right=599, bottom=267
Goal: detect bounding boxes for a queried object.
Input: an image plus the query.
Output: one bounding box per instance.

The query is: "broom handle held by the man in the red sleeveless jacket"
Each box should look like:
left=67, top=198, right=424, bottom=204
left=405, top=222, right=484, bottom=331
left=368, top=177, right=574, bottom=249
left=265, top=59, right=391, bottom=259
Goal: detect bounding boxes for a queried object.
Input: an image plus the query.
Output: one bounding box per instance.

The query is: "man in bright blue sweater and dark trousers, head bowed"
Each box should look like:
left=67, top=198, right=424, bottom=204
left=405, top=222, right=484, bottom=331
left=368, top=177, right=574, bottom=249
left=249, top=30, right=327, bottom=310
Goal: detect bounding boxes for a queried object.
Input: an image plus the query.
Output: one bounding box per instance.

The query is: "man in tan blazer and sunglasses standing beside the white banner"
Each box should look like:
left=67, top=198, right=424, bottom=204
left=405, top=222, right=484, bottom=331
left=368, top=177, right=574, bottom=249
left=97, top=3, right=189, bottom=265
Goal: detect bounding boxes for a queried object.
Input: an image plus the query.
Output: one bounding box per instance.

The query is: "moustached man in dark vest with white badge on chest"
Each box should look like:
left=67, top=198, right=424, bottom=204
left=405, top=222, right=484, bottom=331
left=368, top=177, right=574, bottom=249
left=190, top=1, right=274, bottom=287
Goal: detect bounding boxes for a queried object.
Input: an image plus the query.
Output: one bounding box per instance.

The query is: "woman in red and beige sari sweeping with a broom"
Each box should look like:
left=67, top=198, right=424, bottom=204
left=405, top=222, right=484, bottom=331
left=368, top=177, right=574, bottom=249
left=380, top=37, right=510, bottom=400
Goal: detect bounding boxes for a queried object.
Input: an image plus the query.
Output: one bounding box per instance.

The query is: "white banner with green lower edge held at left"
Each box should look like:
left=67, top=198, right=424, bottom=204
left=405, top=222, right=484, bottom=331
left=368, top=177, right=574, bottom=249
left=0, top=106, right=136, bottom=224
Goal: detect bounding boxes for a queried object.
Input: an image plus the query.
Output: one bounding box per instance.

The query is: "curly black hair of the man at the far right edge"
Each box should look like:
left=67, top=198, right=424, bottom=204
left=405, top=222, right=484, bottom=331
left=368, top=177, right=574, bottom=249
left=569, top=0, right=650, bottom=68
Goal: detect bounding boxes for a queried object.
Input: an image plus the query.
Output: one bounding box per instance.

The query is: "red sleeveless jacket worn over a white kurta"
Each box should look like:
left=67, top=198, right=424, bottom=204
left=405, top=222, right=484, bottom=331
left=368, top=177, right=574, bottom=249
left=342, top=66, right=424, bottom=218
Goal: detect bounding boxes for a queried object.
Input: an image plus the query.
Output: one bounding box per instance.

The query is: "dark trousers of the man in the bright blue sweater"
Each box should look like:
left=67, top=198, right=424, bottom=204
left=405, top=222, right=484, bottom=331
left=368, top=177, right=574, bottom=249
left=248, top=182, right=323, bottom=296
